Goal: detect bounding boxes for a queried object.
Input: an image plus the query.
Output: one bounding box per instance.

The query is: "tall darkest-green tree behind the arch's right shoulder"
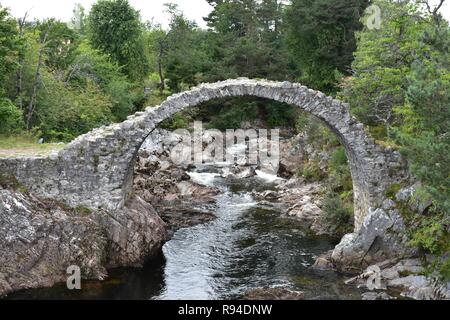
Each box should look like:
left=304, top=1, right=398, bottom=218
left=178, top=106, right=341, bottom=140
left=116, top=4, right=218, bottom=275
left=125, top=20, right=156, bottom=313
left=286, top=0, right=368, bottom=94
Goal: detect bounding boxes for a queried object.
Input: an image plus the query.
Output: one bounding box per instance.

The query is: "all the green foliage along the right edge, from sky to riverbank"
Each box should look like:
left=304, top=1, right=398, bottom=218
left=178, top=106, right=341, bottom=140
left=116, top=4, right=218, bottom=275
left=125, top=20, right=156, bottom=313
left=341, top=0, right=450, bottom=279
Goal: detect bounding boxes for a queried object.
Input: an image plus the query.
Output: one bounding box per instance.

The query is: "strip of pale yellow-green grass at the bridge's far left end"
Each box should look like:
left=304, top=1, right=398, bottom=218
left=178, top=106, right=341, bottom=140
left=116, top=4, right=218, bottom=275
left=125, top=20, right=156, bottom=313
left=0, top=135, right=65, bottom=158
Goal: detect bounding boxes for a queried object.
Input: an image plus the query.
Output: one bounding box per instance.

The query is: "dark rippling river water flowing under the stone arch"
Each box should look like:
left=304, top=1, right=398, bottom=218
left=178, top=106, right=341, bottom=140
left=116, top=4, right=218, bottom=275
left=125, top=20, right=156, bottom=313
left=8, top=168, right=361, bottom=300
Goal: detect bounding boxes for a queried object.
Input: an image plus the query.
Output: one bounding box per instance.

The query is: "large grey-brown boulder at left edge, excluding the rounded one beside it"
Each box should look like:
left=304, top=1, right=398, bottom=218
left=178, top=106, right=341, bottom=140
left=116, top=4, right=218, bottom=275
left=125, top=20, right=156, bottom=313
left=0, top=189, right=106, bottom=296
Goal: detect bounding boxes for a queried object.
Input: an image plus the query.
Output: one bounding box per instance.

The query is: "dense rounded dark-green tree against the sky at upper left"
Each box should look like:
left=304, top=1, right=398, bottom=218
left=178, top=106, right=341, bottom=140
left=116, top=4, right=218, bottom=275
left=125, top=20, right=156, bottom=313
left=88, top=0, right=148, bottom=80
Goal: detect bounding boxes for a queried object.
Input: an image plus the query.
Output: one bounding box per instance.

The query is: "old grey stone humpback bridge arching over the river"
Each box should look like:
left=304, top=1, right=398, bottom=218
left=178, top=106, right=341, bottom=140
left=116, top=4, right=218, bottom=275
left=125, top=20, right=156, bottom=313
left=0, top=78, right=406, bottom=231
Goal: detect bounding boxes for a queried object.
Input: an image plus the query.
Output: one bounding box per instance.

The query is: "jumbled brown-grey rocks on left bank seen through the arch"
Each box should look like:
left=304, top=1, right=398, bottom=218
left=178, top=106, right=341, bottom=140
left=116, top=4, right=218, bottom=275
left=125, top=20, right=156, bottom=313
left=133, top=129, right=218, bottom=236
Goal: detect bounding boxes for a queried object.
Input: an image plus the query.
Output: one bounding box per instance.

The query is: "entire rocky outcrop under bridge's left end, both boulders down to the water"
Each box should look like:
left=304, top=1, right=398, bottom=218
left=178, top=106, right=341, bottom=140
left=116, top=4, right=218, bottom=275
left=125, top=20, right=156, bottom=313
left=0, top=177, right=167, bottom=296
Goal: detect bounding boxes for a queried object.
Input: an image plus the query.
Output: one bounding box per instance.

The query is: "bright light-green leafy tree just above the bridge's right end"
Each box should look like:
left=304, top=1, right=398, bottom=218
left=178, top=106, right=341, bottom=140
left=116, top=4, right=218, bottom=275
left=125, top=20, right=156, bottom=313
left=341, top=0, right=428, bottom=130
